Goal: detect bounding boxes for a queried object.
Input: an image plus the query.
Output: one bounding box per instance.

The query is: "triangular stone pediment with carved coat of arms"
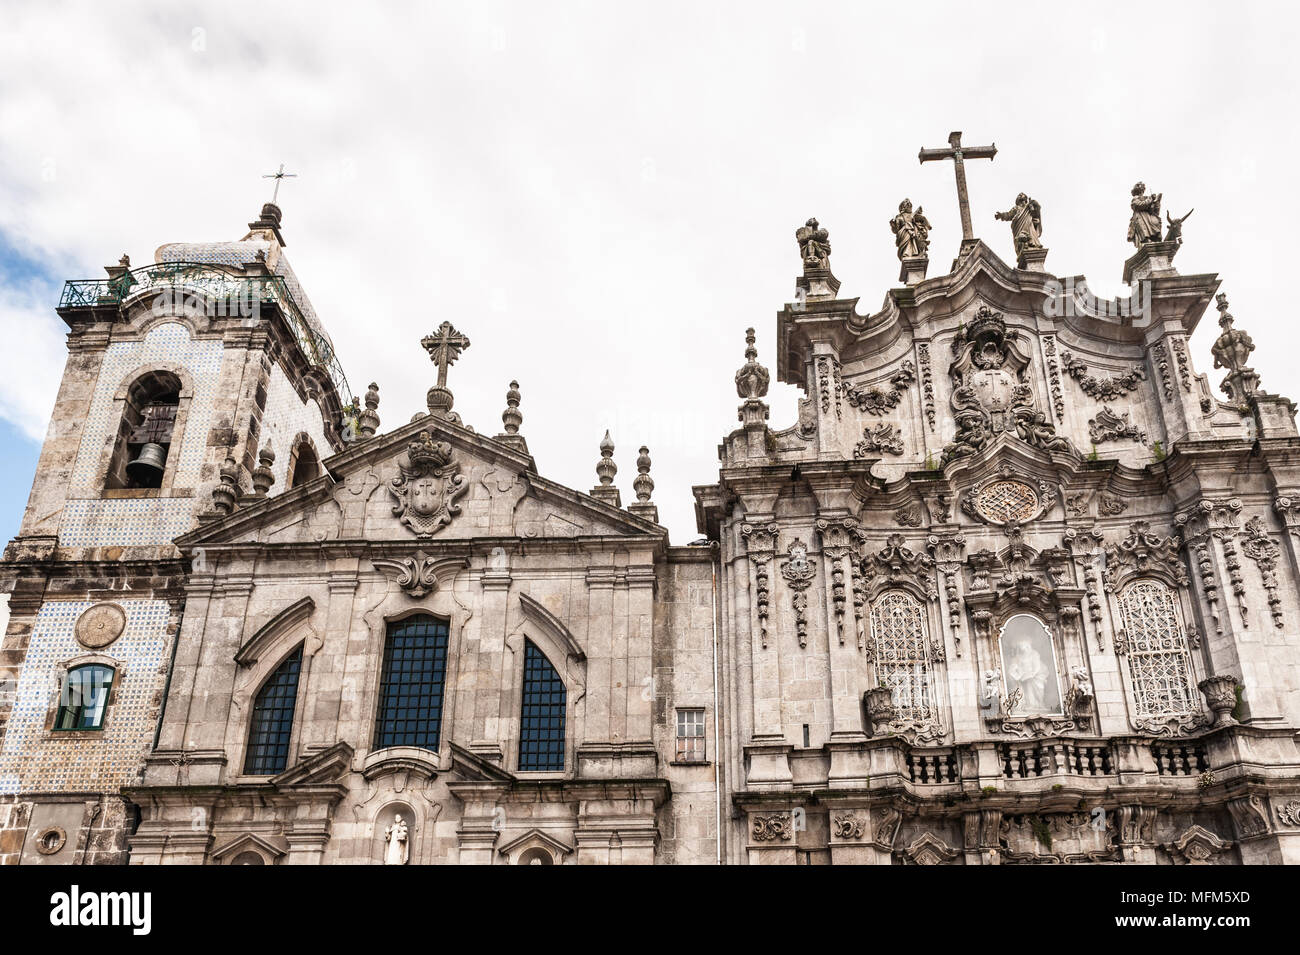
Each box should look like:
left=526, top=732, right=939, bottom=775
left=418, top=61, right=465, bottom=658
left=177, top=416, right=667, bottom=550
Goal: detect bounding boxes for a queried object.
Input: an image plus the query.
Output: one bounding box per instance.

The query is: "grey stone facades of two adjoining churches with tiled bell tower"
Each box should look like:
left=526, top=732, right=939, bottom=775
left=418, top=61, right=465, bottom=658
left=0, top=143, right=1300, bottom=865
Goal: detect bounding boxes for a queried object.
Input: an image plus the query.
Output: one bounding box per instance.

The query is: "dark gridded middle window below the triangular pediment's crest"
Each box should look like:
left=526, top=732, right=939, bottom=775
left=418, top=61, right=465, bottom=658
left=374, top=615, right=447, bottom=750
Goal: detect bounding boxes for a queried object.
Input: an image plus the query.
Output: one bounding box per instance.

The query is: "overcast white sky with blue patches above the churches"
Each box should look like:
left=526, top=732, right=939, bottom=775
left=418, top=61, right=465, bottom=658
left=0, top=0, right=1300, bottom=543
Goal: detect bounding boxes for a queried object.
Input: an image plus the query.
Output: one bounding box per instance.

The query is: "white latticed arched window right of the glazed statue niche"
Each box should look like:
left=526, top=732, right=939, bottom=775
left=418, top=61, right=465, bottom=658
left=1119, top=579, right=1200, bottom=720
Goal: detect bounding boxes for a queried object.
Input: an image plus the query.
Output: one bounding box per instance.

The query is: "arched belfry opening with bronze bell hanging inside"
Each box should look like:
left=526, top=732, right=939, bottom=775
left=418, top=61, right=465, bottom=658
left=104, top=372, right=181, bottom=490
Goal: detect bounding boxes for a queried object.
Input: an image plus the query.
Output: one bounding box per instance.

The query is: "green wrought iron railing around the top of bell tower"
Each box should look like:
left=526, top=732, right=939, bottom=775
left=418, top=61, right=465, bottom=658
left=59, top=262, right=354, bottom=407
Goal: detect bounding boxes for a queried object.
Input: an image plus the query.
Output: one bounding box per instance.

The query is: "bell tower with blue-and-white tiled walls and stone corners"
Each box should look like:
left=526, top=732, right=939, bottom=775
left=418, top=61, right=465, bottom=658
left=0, top=204, right=355, bottom=863
